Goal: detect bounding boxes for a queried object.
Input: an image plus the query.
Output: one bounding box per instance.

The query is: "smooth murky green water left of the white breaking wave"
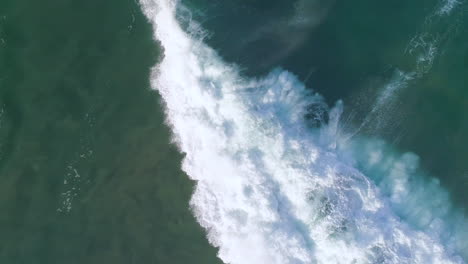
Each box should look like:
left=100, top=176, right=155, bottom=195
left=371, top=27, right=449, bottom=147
left=0, top=0, right=218, bottom=264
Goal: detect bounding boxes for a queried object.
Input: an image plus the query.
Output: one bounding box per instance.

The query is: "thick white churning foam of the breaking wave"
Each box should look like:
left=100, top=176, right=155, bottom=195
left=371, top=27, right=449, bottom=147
left=141, top=0, right=466, bottom=264
